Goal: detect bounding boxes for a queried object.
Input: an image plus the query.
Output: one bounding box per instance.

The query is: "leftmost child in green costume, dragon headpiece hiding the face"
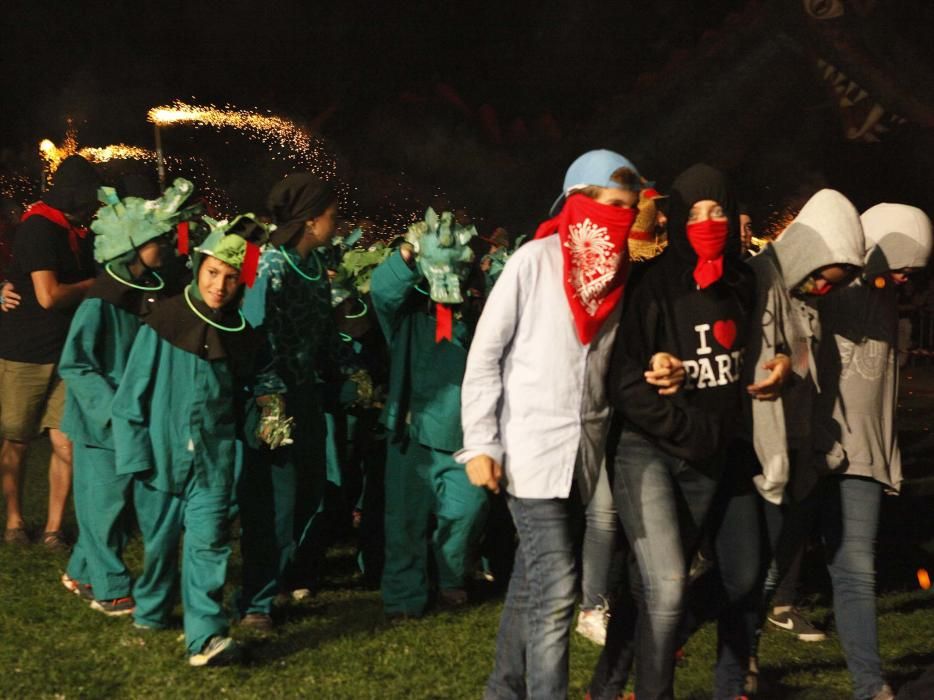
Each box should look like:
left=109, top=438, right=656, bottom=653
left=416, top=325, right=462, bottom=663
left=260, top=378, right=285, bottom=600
left=58, top=178, right=198, bottom=615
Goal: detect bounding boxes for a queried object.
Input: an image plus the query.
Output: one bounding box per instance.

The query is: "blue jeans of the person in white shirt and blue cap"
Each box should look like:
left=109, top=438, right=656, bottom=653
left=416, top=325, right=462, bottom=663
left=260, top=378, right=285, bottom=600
left=484, top=495, right=576, bottom=700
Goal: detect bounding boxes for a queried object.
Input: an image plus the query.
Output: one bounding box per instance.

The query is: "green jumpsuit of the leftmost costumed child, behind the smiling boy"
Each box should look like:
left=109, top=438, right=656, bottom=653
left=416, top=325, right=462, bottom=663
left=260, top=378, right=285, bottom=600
left=58, top=292, right=148, bottom=600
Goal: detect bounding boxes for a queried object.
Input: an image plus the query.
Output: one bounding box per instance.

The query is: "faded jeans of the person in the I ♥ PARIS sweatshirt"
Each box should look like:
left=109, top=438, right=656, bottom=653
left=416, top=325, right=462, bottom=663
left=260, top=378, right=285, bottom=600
left=604, top=429, right=717, bottom=700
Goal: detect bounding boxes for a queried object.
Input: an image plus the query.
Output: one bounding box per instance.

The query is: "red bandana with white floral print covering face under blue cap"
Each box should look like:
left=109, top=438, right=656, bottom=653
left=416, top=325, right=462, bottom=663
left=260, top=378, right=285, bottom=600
left=535, top=194, right=636, bottom=345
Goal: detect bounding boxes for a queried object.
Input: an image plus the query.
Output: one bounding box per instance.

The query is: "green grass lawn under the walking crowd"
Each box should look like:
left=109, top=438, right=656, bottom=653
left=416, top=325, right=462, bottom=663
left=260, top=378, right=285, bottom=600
left=0, top=441, right=934, bottom=700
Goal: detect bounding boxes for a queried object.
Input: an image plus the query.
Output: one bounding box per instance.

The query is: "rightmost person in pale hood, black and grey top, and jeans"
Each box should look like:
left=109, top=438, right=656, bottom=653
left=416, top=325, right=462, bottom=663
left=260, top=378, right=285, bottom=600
left=809, top=204, right=931, bottom=700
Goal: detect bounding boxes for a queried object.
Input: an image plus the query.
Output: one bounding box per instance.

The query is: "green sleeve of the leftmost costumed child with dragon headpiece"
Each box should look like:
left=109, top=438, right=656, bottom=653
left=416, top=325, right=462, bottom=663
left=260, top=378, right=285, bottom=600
left=58, top=299, right=116, bottom=431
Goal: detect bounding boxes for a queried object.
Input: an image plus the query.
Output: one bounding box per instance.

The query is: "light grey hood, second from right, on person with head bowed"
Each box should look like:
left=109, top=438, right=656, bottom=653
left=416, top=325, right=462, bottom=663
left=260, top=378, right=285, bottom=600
left=772, top=189, right=866, bottom=291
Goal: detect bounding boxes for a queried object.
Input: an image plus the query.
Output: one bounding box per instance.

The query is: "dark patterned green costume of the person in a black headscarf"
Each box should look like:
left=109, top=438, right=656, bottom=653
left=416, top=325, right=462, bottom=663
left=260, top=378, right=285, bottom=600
left=238, top=248, right=340, bottom=615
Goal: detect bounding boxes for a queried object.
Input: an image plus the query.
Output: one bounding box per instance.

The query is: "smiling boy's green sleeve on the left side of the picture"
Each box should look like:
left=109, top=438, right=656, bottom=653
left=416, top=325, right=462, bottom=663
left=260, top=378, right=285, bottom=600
left=113, top=326, right=162, bottom=474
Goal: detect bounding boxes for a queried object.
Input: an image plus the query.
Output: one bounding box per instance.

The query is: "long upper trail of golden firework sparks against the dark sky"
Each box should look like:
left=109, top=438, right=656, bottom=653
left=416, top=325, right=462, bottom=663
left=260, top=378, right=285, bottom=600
left=147, top=100, right=337, bottom=180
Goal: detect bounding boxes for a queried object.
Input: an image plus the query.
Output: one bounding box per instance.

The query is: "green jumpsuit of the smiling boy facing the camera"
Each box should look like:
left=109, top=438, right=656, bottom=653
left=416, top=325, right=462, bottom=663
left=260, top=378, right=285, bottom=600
left=113, top=320, right=236, bottom=654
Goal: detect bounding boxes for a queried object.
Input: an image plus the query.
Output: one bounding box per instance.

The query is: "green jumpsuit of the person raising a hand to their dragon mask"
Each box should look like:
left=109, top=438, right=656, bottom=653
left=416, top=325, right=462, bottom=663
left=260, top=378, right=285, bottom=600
left=371, top=252, right=487, bottom=616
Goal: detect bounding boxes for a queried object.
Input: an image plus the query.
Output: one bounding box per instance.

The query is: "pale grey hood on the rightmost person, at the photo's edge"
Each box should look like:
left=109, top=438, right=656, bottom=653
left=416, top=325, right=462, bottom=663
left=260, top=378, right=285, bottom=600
left=860, top=204, right=931, bottom=277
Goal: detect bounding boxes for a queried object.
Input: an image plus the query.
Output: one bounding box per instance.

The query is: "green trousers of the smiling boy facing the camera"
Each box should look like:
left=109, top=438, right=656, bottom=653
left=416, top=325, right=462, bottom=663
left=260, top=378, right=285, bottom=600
left=133, top=478, right=230, bottom=654
